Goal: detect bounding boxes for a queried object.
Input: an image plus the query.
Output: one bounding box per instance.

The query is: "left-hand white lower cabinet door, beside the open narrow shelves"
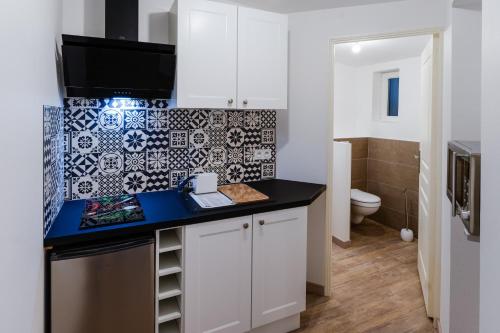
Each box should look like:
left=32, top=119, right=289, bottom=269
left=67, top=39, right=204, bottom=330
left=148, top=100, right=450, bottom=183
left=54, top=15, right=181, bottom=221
left=184, top=216, right=252, bottom=333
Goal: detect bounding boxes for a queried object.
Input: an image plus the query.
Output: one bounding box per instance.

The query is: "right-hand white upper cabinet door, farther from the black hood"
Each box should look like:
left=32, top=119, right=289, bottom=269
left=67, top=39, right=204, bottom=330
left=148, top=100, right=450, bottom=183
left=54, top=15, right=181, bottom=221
left=238, top=7, right=288, bottom=109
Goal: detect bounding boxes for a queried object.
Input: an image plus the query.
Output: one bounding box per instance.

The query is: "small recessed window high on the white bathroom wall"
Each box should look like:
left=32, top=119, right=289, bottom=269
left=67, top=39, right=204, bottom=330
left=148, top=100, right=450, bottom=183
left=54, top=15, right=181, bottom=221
left=373, top=70, right=399, bottom=121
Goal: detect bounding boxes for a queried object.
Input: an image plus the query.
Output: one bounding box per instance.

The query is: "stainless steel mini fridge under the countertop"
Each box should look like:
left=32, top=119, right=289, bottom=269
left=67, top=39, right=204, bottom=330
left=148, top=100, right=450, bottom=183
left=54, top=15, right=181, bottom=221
left=50, top=238, right=155, bottom=333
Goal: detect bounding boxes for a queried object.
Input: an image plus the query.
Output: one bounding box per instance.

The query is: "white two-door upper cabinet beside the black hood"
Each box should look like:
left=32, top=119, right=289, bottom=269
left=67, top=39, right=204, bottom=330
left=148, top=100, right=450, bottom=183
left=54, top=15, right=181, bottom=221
left=177, top=0, right=288, bottom=109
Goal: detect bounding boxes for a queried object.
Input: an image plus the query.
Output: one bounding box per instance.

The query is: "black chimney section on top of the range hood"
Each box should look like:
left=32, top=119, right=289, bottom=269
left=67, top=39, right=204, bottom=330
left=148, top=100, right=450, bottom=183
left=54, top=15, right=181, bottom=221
left=105, top=0, right=139, bottom=42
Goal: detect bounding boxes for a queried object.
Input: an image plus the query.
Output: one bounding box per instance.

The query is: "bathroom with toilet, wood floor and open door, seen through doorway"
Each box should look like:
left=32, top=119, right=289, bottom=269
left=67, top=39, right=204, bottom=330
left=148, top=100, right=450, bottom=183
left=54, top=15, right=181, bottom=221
left=322, top=34, right=439, bottom=330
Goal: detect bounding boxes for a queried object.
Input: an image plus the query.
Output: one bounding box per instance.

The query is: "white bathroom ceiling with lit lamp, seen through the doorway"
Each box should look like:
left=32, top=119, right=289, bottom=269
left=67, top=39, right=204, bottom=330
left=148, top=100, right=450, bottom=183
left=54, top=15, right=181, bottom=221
left=335, top=35, right=431, bottom=66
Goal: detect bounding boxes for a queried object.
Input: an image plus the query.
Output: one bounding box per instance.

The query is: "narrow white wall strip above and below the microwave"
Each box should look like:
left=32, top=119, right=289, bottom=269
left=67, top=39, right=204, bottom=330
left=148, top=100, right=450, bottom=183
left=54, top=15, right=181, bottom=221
left=443, top=8, right=481, bottom=333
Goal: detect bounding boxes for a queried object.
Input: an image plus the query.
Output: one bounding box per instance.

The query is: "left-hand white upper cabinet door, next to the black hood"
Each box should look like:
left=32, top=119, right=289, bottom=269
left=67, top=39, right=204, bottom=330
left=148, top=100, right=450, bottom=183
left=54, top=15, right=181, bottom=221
left=177, top=0, right=237, bottom=108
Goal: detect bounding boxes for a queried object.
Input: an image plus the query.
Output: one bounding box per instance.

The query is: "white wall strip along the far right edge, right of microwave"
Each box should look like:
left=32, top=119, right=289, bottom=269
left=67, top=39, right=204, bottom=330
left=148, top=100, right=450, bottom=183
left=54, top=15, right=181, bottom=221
left=480, top=0, right=500, bottom=333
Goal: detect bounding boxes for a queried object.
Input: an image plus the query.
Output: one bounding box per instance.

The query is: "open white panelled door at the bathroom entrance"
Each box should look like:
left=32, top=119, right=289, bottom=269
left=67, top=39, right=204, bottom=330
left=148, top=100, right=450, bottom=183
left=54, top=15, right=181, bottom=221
left=418, top=39, right=439, bottom=317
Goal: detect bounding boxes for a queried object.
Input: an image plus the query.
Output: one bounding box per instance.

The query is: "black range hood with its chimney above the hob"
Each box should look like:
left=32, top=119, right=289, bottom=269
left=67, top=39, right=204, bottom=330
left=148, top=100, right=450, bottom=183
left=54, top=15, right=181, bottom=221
left=62, top=0, right=176, bottom=98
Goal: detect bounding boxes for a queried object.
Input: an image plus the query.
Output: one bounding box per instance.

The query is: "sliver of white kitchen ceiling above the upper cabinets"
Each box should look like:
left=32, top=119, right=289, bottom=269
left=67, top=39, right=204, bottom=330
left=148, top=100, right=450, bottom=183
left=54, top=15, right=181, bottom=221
left=215, top=0, right=403, bottom=13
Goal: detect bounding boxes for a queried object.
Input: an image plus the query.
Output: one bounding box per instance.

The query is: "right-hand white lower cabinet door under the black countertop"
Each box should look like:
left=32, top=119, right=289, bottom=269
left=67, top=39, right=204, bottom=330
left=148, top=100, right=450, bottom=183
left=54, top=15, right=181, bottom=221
left=252, top=207, right=307, bottom=328
